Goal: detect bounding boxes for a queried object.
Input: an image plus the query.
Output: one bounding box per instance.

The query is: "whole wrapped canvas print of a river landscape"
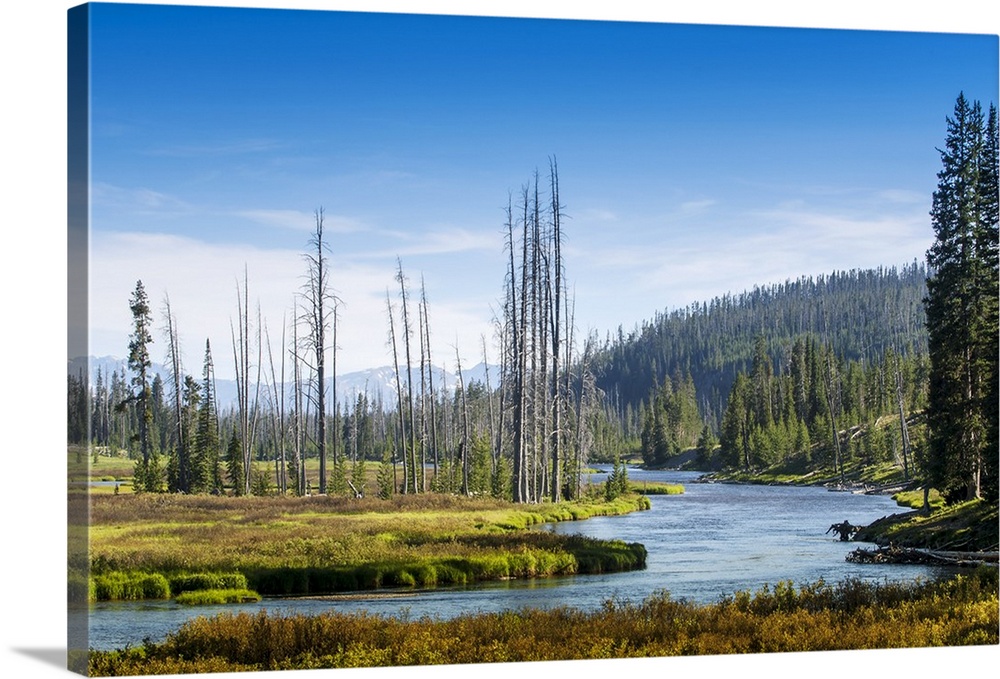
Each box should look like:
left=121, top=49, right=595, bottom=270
left=67, top=3, right=998, bottom=676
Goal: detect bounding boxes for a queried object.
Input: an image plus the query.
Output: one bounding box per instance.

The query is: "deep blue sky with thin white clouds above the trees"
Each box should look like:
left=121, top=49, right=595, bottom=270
left=82, top=4, right=998, bottom=374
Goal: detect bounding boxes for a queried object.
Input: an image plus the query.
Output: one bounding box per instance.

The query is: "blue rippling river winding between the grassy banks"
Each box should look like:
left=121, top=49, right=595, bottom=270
left=90, top=469, right=945, bottom=649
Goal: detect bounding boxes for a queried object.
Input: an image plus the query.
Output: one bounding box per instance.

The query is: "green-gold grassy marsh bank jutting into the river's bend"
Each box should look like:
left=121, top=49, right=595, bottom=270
left=90, top=494, right=650, bottom=595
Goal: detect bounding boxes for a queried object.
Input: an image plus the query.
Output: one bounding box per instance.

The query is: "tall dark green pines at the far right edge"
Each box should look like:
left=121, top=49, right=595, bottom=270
left=924, top=94, right=997, bottom=501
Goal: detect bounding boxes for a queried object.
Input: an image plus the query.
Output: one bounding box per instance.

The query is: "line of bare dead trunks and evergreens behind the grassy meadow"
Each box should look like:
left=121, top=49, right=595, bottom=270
left=69, top=158, right=600, bottom=502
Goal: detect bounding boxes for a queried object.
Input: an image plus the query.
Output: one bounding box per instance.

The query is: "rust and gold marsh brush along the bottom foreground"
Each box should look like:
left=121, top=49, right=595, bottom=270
left=89, top=569, right=998, bottom=676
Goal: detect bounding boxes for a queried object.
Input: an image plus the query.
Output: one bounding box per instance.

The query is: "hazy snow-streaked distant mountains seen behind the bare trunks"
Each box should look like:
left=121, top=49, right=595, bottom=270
left=67, top=356, right=500, bottom=410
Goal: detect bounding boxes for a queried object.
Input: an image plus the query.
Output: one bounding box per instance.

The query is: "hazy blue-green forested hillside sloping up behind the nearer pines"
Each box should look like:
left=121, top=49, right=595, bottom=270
left=592, top=262, right=927, bottom=431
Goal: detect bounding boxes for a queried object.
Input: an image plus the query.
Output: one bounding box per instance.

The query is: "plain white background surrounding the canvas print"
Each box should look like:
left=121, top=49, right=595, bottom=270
left=0, top=0, right=1000, bottom=679
